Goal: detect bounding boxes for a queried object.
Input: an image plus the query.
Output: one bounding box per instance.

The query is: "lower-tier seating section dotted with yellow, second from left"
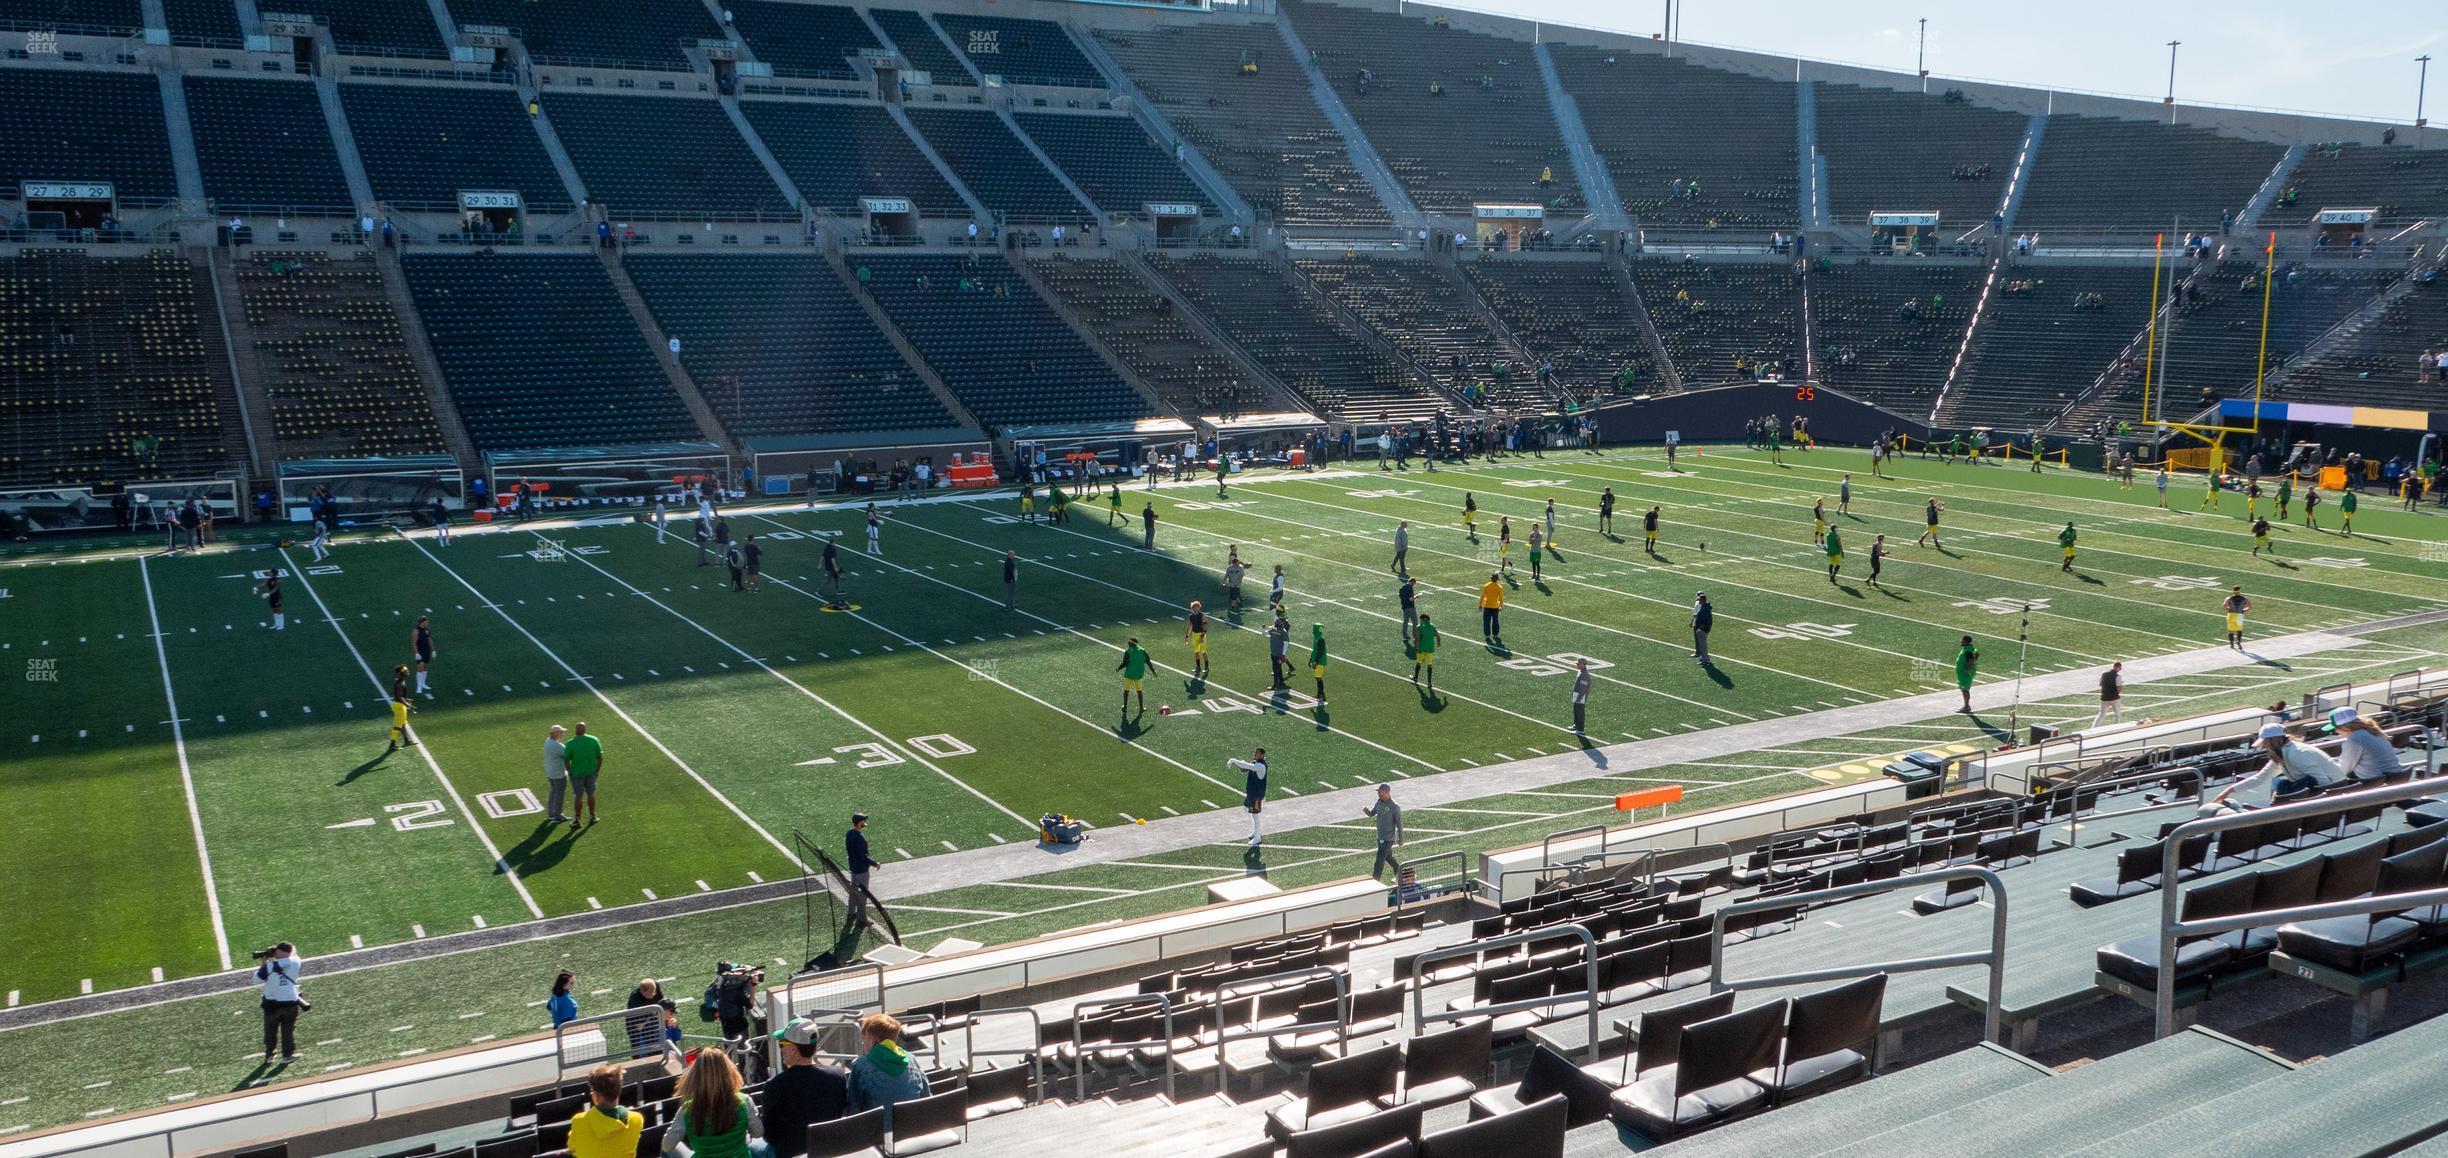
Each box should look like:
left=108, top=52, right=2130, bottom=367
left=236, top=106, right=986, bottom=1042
left=237, top=250, right=443, bottom=458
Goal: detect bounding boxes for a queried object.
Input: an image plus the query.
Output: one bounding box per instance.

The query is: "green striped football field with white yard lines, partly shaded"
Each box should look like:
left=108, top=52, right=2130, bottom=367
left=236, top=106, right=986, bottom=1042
left=0, top=450, right=2448, bottom=1134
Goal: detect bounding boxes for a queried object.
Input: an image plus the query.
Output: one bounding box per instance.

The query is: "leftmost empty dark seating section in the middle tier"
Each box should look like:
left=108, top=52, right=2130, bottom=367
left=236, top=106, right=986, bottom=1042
left=0, top=69, right=181, bottom=206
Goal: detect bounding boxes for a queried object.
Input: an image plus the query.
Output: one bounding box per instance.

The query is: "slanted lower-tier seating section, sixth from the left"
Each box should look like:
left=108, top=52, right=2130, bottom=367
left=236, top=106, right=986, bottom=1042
left=1031, top=250, right=1268, bottom=414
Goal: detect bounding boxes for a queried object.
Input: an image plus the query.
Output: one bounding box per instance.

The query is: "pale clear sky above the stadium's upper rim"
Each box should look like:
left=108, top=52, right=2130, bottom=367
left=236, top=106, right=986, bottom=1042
left=1447, top=0, right=2448, bottom=127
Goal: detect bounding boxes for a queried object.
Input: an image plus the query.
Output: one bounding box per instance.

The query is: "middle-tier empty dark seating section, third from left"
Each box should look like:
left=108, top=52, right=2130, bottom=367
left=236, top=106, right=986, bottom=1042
left=340, top=83, right=573, bottom=213
